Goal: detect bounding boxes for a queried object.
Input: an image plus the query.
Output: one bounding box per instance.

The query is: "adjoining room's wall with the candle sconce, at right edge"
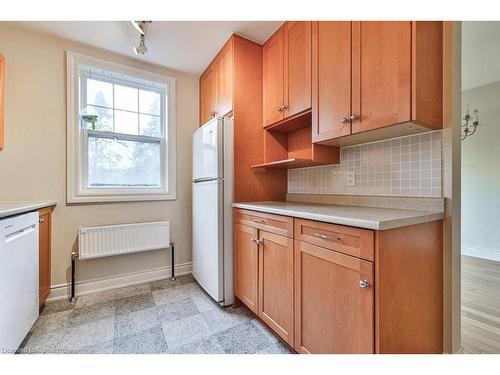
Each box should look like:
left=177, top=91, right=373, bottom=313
left=462, top=81, right=500, bottom=261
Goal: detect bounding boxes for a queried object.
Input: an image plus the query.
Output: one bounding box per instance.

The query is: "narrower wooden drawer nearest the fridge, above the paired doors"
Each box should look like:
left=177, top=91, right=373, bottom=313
left=234, top=209, right=293, bottom=237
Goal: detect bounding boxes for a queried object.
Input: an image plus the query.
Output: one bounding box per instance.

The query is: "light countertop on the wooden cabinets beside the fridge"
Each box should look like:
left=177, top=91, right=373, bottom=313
left=233, top=202, right=444, bottom=230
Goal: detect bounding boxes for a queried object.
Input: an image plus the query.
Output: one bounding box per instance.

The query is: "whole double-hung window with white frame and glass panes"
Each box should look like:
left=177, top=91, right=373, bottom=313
left=67, top=52, right=175, bottom=203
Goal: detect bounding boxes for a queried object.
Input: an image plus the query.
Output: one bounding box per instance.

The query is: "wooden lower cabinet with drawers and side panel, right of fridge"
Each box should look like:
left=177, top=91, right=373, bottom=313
left=234, top=209, right=443, bottom=354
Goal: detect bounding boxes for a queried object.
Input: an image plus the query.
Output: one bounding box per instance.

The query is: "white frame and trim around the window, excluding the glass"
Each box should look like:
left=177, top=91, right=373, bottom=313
left=66, top=51, right=177, bottom=203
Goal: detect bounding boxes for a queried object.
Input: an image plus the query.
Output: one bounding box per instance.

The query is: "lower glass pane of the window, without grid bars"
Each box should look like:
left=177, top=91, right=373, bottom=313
left=88, top=135, right=161, bottom=188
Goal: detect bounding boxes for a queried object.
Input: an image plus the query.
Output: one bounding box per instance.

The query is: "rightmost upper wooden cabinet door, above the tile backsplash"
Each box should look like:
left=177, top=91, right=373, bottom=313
left=352, top=21, right=411, bottom=133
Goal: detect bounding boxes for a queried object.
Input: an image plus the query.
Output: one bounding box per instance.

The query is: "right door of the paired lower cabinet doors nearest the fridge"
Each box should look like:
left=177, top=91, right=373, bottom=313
left=258, top=231, right=294, bottom=345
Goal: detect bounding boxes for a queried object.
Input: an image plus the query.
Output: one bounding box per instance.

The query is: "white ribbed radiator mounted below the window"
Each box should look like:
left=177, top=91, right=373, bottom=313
left=78, top=220, right=170, bottom=259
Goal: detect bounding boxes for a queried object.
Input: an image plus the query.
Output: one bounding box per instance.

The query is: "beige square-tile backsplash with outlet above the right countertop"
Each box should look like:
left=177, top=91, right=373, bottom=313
left=288, top=131, right=442, bottom=197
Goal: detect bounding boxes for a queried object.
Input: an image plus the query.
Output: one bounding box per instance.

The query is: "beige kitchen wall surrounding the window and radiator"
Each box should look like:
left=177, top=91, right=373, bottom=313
left=0, top=23, right=198, bottom=300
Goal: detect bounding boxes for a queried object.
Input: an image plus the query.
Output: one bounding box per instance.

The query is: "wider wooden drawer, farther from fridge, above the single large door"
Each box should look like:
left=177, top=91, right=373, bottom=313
left=294, top=219, right=375, bottom=261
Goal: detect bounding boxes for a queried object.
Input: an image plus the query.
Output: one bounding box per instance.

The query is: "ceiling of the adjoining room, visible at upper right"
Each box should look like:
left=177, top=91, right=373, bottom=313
left=462, top=21, right=500, bottom=91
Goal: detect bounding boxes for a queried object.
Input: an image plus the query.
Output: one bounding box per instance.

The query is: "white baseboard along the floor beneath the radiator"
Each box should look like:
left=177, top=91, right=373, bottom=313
left=47, top=262, right=193, bottom=301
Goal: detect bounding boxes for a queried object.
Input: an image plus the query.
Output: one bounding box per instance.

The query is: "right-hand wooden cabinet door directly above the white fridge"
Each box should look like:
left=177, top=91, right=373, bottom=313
left=216, top=40, right=233, bottom=116
